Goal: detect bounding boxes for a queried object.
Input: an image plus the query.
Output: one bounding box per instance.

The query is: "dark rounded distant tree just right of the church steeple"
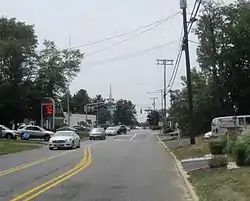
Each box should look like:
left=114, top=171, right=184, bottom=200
left=114, top=99, right=137, bottom=125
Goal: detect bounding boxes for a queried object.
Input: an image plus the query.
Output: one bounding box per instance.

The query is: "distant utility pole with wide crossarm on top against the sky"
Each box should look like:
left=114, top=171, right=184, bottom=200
left=156, top=59, right=174, bottom=119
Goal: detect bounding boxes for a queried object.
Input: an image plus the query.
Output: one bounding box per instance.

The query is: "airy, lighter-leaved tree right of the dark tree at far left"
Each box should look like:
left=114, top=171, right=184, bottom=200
left=36, top=40, right=83, bottom=97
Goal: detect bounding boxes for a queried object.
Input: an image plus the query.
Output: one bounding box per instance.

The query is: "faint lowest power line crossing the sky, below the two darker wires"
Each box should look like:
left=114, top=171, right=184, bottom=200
left=86, top=40, right=177, bottom=66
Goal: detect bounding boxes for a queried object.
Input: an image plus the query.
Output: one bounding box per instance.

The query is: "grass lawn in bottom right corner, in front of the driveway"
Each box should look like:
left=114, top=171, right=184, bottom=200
left=189, top=167, right=250, bottom=201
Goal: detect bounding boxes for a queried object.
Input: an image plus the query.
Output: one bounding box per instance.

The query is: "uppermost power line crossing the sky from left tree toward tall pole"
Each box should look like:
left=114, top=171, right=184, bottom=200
left=71, top=12, right=180, bottom=49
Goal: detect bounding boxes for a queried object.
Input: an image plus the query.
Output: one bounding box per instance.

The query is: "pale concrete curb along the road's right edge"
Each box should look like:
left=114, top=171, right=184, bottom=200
left=156, top=135, right=199, bottom=201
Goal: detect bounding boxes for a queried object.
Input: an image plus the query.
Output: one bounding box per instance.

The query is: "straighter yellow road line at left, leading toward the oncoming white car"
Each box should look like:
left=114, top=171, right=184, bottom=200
left=0, top=150, right=76, bottom=177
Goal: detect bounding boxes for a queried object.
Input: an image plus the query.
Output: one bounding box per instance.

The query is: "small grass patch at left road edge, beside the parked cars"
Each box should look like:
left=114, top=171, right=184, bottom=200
left=0, top=140, right=40, bottom=155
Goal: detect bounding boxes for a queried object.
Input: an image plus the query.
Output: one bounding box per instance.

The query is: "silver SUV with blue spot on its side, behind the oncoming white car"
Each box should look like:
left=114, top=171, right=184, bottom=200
left=18, top=125, right=54, bottom=141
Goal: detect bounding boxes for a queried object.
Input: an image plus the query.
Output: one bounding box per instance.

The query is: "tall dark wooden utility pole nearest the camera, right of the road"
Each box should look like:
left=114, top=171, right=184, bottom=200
left=180, top=0, right=195, bottom=144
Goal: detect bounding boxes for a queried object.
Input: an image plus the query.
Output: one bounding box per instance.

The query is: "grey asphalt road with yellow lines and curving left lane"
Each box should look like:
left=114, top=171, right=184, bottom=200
left=0, top=130, right=190, bottom=201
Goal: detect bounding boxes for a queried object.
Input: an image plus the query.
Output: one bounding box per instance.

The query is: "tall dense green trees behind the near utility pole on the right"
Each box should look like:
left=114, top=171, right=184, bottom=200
left=168, top=0, right=250, bottom=135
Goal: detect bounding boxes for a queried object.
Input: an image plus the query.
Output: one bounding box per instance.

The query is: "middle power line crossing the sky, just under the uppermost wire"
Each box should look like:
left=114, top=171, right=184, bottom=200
left=86, top=12, right=180, bottom=56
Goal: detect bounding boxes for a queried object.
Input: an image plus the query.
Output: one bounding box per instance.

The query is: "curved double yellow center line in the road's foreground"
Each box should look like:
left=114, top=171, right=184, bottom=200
left=11, top=147, right=92, bottom=201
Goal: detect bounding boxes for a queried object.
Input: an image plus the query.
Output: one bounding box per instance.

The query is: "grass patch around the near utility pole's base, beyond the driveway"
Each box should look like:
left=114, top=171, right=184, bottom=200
left=163, top=137, right=210, bottom=160
